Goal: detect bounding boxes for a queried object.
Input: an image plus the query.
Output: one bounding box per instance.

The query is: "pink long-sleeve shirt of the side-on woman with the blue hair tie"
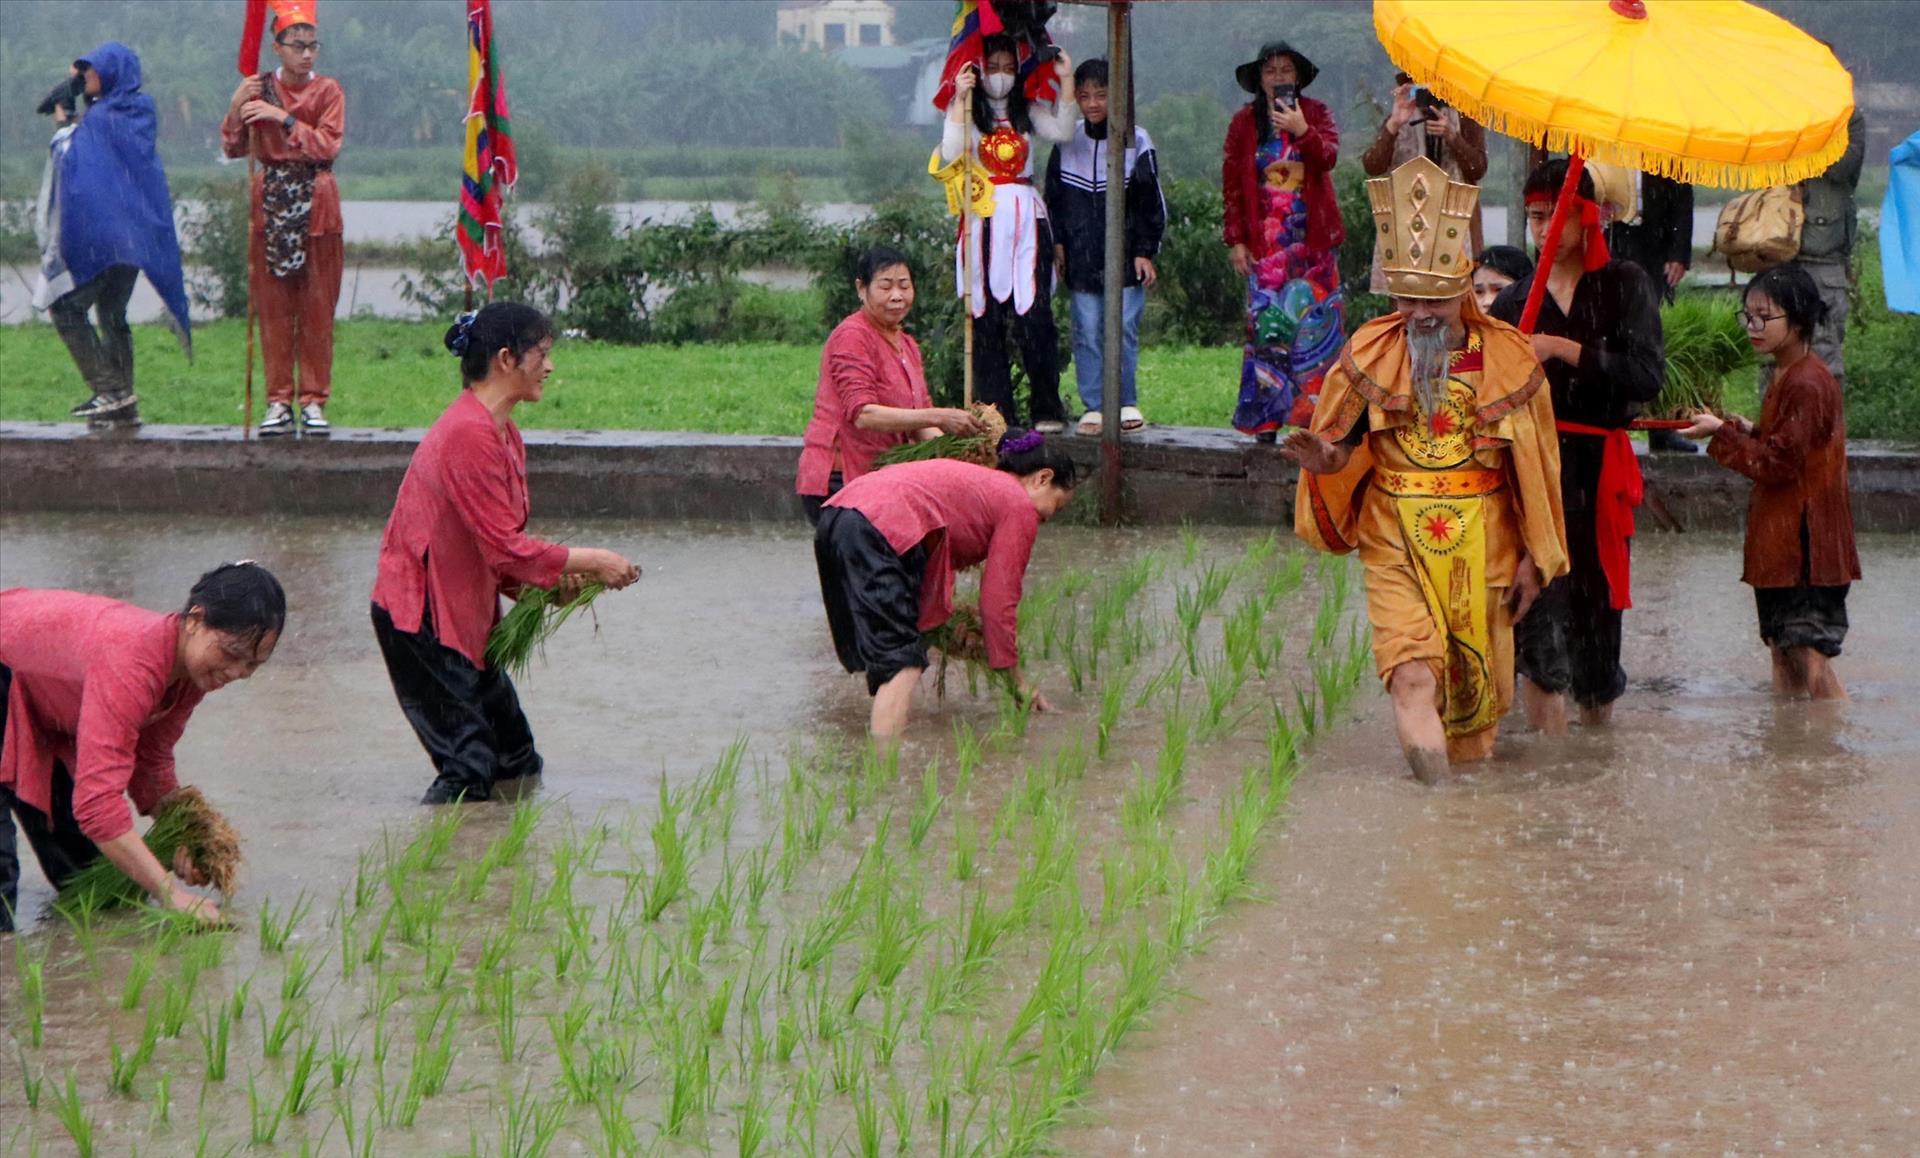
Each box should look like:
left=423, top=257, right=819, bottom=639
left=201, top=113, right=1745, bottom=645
left=372, top=390, right=566, bottom=666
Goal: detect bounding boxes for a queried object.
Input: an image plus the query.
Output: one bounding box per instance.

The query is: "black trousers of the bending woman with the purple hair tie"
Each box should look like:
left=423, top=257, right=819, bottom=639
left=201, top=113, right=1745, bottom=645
left=814, top=507, right=927, bottom=695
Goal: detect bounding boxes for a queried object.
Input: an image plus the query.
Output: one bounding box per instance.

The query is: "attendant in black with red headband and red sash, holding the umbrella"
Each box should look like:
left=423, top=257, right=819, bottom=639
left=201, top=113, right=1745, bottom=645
left=1492, top=161, right=1667, bottom=732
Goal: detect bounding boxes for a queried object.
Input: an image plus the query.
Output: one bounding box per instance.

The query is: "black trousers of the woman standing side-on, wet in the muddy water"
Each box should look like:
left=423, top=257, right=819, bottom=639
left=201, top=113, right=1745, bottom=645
left=372, top=603, right=541, bottom=805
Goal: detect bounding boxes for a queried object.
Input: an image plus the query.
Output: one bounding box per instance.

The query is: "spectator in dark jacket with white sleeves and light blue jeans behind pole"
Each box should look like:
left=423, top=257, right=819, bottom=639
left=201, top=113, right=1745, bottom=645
left=1046, top=60, right=1167, bottom=434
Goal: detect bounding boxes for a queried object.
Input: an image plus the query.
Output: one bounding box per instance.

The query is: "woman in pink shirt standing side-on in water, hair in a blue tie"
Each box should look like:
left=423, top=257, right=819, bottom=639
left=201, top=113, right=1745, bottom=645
left=372, top=302, right=639, bottom=805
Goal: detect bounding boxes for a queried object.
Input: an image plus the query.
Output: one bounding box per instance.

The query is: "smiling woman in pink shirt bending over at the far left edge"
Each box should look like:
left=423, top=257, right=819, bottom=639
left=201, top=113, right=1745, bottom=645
left=0, top=563, right=286, bottom=931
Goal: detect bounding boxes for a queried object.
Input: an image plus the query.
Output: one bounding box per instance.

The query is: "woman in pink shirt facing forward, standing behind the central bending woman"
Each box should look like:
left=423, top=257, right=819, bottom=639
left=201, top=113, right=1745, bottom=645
left=793, top=246, right=981, bottom=522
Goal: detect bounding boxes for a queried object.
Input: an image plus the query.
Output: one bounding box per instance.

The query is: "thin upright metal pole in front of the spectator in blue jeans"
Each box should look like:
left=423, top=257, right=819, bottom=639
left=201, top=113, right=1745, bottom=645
left=1105, top=0, right=1133, bottom=526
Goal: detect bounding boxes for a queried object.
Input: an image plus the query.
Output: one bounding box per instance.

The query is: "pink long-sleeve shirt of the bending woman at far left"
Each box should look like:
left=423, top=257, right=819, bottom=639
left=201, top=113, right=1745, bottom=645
left=0, top=588, right=202, bottom=843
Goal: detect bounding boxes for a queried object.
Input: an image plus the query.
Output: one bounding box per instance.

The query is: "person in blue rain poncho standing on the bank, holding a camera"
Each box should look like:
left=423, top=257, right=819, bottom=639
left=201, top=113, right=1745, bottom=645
left=33, top=42, right=192, bottom=426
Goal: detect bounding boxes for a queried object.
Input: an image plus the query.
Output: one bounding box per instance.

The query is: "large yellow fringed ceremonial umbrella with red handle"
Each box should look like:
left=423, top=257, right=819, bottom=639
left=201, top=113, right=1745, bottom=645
left=1373, top=0, right=1853, bottom=330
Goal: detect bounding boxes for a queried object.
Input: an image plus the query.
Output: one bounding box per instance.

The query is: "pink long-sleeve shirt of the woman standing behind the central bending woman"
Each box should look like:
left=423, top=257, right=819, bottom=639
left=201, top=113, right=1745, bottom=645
left=793, top=309, right=933, bottom=495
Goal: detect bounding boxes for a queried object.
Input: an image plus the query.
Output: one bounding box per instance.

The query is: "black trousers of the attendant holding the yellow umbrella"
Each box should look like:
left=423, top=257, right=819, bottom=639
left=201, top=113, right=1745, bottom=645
left=1513, top=511, right=1626, bottom=709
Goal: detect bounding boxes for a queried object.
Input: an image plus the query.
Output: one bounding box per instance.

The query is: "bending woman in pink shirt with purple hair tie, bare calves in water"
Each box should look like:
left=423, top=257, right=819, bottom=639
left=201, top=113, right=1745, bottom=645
left=814, top=430, right=1075, bottom=737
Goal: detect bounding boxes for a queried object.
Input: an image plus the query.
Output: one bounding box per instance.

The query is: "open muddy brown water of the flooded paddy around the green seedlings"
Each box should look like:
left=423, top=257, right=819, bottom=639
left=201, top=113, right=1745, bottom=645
left=0, top=517, right=1920, bottom=1154
